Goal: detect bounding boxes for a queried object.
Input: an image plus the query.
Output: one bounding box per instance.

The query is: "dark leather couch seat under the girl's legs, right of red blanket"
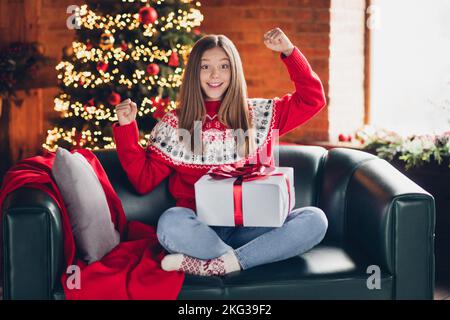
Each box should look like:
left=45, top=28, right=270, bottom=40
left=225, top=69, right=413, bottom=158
left=178, top=245, right=393, bottom=300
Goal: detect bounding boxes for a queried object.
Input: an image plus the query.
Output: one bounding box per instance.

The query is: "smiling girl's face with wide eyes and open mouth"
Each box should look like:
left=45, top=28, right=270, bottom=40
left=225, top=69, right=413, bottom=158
left=200, top=47, right=231, bottom=101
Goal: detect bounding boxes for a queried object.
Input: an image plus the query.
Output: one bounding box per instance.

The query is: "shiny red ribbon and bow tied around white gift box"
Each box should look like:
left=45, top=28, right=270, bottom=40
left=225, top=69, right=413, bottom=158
left=208, top=164, right=291, bottom=226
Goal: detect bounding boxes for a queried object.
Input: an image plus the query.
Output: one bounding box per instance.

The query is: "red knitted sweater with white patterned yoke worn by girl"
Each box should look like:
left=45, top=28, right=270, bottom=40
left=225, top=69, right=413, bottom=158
left=113, top=47, right=326, bottom=211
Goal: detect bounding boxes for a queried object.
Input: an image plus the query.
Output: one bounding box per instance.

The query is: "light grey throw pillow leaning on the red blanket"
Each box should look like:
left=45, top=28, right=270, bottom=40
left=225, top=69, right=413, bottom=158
left=52, top=148, right=120, bottom=264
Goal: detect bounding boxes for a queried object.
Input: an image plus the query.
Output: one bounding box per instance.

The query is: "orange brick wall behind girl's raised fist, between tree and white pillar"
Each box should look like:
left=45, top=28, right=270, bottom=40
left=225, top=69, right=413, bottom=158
left=201, top=0, right=330, bottom=141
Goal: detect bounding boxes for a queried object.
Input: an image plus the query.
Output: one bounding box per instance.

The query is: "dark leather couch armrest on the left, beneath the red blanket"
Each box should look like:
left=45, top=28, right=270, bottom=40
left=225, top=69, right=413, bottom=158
left=2, top=188, right=64, bottom=299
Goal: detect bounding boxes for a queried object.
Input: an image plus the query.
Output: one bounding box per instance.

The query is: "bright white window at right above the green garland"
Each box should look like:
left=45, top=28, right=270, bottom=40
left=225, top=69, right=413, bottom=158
left=370, top=0, right=450, bottom=135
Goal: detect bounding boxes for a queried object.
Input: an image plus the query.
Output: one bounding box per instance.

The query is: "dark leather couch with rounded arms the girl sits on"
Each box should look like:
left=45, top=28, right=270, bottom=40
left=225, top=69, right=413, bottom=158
left=2, top=146, right=435, bottom=299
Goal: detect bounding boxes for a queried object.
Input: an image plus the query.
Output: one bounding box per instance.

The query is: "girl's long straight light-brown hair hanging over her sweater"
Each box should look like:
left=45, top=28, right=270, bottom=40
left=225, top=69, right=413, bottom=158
left=177, top=34, right=255, bottom=159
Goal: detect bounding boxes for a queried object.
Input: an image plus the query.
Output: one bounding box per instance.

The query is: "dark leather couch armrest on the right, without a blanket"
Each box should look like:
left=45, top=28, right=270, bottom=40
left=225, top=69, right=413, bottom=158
left=344, top=159, right=435, bottom=299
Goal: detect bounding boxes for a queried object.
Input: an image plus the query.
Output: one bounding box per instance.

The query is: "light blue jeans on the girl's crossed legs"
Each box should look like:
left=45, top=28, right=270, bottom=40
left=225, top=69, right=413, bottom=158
left=157, top=207, right=328, bottom=270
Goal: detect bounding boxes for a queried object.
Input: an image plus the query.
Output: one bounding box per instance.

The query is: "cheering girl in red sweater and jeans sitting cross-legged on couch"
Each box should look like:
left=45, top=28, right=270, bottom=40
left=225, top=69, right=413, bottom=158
left=113, top=28, right=328, bottom=276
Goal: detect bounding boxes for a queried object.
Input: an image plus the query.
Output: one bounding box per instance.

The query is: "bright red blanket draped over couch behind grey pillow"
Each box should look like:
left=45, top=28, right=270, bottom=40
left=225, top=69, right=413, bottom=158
left=0, top=149, right=184, bottom=300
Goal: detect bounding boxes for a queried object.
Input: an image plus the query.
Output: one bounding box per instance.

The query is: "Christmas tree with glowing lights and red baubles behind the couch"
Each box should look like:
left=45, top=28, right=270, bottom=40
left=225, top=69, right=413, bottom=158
left=42, top=0, right=203, bottom=151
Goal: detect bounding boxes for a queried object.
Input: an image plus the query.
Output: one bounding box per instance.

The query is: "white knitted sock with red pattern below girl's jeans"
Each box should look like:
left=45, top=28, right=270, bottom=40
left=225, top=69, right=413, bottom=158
left=161, top=251, right=241, bottom=276
